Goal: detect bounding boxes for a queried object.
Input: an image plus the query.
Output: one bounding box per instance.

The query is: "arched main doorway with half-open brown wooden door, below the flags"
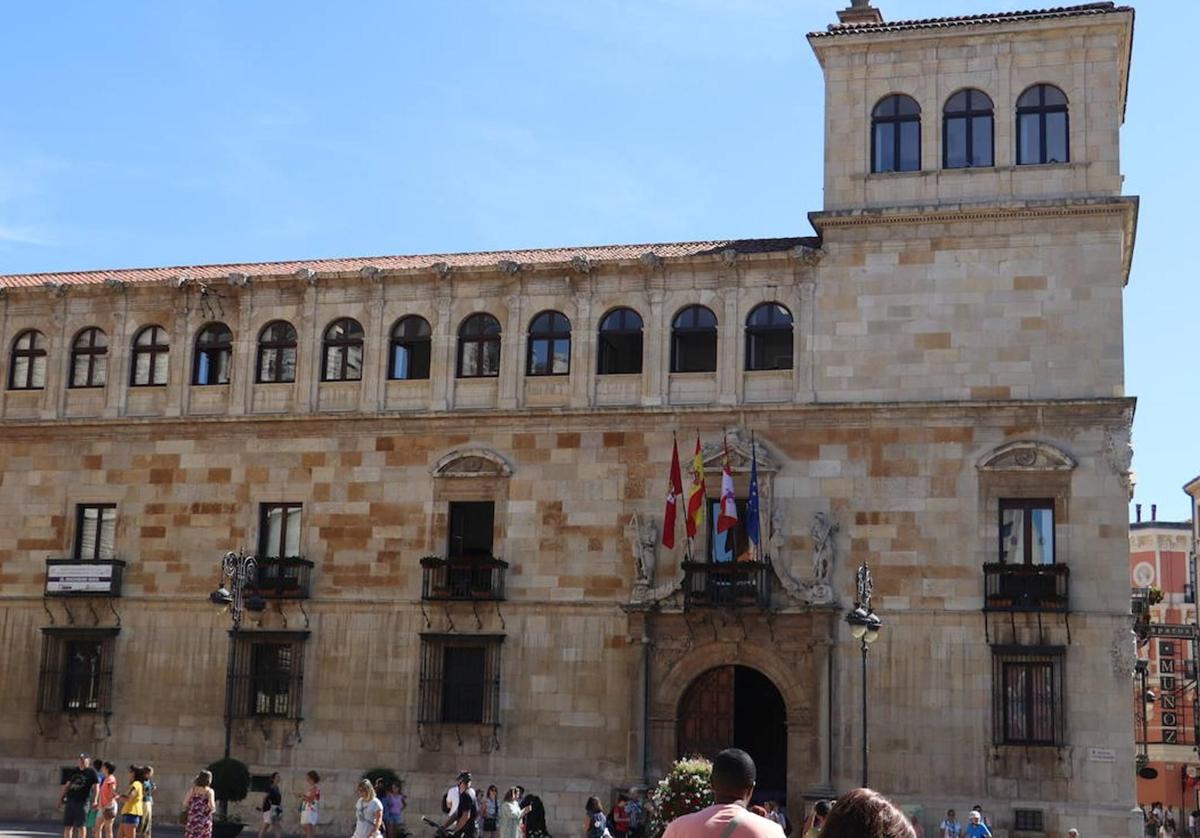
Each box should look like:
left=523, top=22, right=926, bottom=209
left=676, top=665, right=787, bottom=802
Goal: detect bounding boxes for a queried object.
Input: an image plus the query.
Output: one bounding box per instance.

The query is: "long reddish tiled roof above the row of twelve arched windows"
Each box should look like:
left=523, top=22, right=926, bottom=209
left=0, top=237, right=817, bottom=288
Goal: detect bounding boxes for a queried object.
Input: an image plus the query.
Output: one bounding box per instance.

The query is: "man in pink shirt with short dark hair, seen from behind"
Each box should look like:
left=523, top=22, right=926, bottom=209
left=662, top=748, right=784, bottom=838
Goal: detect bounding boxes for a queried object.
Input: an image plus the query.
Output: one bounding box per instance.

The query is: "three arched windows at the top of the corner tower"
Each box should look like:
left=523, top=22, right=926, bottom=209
left=871, top=84, right=1070, bottom=173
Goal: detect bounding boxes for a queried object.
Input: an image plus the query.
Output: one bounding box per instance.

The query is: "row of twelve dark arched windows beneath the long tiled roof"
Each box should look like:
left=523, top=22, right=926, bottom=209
left=8, top=303, right=793, bottom=390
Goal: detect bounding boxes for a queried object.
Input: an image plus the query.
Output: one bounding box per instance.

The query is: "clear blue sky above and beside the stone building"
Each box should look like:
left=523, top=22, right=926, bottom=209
left=0, top=0, right=1185, bottom=517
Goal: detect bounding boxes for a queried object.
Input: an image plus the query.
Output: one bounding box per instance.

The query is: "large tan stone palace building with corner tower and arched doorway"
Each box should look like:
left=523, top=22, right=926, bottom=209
left=0, top=1, right=1138, bottom=836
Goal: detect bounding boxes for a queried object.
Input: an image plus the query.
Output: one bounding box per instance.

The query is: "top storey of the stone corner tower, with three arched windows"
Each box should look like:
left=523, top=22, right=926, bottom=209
left=809, top=0, right=1134, bottom=211
